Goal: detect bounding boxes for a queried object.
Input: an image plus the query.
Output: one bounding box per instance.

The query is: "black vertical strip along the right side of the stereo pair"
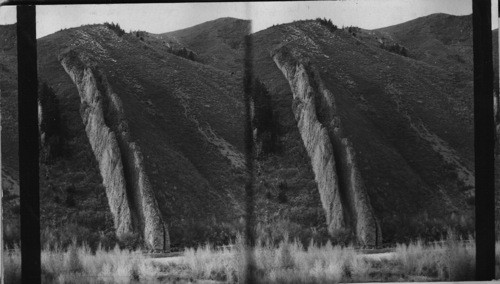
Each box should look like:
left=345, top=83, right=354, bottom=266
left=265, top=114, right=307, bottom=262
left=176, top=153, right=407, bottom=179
left=472, top=0, right=498, bottom=280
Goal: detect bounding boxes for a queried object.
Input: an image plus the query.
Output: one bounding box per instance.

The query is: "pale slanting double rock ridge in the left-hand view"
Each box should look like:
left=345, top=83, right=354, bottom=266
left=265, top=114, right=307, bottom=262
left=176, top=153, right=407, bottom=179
left=59, top=50, right=170, bottom=250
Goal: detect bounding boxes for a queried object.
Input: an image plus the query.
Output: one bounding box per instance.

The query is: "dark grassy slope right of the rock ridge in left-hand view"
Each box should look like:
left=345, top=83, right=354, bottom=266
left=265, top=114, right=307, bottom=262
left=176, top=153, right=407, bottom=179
left=39, top=25, right=244, bottom=247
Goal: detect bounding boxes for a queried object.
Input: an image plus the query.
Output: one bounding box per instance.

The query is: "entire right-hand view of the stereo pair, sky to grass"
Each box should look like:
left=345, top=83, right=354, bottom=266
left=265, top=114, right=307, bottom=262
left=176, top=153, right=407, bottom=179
left=251, top=1, right=490, bottom=282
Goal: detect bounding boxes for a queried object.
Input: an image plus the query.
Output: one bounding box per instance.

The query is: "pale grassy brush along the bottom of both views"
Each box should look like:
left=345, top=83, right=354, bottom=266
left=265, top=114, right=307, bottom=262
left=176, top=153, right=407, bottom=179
left=4, top=233, right=500, bottom=283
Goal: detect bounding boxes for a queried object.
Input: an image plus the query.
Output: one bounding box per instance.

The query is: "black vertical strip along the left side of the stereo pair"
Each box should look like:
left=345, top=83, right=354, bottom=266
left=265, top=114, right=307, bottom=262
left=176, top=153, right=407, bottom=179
left=17, top=6, right=41, bottom=283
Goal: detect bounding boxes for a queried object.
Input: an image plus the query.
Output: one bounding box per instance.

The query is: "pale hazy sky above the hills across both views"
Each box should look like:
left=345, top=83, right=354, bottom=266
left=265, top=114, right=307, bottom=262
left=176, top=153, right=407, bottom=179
left=0, top=0, right=498, bottom=37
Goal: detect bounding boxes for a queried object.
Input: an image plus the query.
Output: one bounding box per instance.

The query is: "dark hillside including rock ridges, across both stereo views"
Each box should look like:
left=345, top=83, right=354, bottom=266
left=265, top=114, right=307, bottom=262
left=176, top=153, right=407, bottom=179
left=0, top=14, right=492, bottom=249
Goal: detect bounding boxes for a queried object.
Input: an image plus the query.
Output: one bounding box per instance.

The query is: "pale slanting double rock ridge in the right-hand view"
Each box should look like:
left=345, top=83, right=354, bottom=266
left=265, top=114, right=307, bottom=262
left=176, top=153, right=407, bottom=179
left=272, top=47, right=382, bottom=246
